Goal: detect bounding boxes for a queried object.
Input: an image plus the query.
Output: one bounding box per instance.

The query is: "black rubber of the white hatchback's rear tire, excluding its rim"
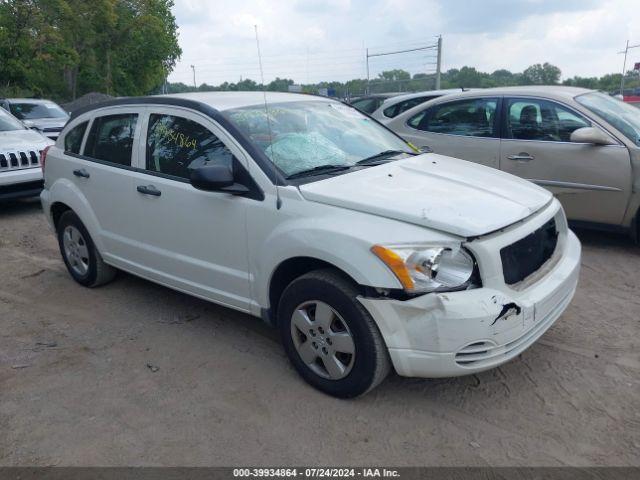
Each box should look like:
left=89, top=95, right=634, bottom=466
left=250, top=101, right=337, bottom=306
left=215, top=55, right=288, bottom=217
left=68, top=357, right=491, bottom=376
left=57, top=210, right=116, bottom=287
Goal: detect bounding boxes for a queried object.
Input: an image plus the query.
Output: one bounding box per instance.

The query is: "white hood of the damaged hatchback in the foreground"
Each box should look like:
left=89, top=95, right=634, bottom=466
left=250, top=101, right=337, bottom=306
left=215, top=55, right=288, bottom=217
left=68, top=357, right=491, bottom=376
left=299, top=153, right=552, bottom=237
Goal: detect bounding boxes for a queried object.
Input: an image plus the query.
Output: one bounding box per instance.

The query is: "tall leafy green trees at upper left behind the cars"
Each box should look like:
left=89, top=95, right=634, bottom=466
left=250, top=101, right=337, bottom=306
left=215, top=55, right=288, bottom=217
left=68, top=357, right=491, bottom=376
left=0, top=0, right=182, bottom=100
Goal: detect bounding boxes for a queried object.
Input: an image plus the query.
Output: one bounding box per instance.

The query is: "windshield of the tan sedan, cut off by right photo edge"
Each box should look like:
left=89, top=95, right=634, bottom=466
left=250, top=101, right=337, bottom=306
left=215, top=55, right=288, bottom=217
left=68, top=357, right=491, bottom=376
left=576, top=92, right=640, bottom=146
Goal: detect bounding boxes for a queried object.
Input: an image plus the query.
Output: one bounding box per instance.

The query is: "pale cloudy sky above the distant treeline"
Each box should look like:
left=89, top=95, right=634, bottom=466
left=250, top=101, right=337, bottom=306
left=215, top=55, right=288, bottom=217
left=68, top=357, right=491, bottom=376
left=169, top=0, right=640, bottom=85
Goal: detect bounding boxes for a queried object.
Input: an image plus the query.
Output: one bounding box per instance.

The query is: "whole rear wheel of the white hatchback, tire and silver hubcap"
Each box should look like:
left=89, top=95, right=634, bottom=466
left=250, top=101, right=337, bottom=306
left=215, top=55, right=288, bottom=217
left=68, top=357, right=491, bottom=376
left=57, top=210, right=116, bottom=287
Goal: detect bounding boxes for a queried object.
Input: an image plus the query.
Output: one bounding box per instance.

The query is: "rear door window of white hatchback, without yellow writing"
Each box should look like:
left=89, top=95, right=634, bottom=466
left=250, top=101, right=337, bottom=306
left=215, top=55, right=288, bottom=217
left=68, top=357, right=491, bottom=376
left=84, top=113, right=138, bottom=166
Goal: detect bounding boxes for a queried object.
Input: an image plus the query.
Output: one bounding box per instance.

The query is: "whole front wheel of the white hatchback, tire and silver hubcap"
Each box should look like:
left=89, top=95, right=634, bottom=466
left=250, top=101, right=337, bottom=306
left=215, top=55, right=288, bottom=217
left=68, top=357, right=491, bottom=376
left=278, top=269, right=390, bottom=398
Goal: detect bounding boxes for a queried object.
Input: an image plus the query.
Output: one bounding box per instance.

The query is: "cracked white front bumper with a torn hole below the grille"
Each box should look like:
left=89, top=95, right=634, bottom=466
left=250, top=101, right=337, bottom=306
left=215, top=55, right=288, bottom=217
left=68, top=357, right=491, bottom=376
left=359, top=230, right=581, bottom=378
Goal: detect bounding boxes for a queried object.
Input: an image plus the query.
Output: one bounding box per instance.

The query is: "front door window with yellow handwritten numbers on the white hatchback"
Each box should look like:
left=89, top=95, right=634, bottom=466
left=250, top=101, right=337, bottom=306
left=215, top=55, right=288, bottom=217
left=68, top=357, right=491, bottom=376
left=146, top=114, right=233, bottom=179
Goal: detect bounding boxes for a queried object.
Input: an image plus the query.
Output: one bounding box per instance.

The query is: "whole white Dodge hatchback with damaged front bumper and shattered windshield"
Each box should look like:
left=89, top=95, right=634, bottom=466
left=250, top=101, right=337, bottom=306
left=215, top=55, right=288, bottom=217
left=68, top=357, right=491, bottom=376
left=41, top=92, right=580, bottom=397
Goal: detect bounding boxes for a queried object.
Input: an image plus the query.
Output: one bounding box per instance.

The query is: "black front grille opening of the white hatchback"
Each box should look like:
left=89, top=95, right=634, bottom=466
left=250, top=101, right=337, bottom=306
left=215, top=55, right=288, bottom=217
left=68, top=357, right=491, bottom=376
left=500, top=218, right=558, bottom=285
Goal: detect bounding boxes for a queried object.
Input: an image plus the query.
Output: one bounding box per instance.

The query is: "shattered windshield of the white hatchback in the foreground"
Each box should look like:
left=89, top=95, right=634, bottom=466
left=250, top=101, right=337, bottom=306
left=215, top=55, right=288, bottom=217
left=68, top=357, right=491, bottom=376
left=225, top=101, right=415, bottom=176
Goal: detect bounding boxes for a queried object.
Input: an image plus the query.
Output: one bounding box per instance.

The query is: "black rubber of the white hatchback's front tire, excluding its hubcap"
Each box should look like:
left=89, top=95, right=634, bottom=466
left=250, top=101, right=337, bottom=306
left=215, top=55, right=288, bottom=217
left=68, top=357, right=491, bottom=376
left=278, top=269, right=390, bottom=398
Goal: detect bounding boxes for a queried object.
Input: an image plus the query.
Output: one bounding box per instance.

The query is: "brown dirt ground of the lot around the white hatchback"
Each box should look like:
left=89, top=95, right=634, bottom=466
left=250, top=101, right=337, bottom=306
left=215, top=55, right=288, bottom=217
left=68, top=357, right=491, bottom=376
left=0, top=202, right=640, bottom=466
